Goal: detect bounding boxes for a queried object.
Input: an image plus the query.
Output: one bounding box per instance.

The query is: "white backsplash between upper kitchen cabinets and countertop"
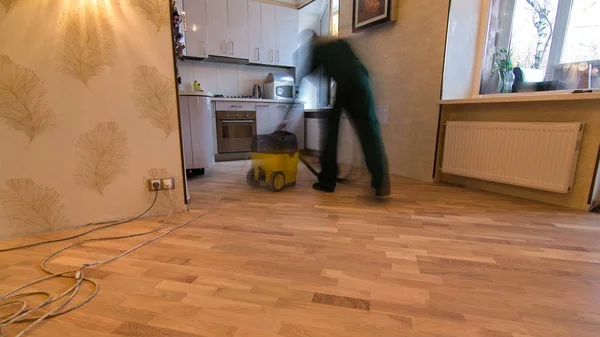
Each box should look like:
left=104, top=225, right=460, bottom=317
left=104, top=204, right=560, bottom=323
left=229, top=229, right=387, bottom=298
left=177, top=60, right=295, bottom=96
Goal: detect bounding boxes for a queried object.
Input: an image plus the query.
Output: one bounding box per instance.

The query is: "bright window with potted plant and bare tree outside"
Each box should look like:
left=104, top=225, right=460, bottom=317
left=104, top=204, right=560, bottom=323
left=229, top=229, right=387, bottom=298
left=480, top=0, right=600, bottom=94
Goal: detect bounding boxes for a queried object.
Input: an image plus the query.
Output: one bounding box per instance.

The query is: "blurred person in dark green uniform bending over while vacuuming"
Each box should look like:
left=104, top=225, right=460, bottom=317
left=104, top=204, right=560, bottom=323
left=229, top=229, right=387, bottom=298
left=298, top=30, right=390, bottom=196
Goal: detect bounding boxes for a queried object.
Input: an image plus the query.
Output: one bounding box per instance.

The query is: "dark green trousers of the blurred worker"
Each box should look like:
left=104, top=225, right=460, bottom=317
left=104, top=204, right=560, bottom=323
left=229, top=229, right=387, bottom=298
left=319, top=75, right=389, bottom=191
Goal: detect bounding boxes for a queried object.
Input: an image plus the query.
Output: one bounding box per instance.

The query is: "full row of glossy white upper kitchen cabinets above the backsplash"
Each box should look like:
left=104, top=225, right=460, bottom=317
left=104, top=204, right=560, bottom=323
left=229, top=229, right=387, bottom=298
left=183, top=0, right=300, bottom=67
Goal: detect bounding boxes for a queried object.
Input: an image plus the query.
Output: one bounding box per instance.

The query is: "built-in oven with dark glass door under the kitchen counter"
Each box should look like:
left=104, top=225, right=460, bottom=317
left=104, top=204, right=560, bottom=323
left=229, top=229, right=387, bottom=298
left=216, top=110, right=256, bottom=160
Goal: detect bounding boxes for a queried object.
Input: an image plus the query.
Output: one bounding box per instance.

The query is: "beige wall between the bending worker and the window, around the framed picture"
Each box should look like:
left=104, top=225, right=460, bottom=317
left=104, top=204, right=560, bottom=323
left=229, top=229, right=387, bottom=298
left=340, top=0, right=450, bottom=181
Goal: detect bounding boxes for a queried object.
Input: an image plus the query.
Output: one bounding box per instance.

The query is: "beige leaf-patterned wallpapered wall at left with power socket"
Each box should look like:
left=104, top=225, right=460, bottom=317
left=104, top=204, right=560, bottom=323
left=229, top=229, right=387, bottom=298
left=0, top=0, right=186, bottom=238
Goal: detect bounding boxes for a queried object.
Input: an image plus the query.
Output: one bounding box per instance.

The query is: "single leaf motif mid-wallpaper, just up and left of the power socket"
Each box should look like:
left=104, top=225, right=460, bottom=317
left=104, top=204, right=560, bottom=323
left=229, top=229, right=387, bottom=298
left=75, top=122, right=129, bottom=195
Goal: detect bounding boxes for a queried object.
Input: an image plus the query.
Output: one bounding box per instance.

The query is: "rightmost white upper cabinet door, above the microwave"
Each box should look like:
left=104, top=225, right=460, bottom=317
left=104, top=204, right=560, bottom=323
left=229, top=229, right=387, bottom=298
left=275, top=6, right=300, bottom=67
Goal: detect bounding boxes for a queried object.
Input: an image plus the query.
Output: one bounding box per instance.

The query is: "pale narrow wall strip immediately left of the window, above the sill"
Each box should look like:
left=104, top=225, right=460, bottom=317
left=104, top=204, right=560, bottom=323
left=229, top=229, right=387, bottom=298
left=442, top=0, right=483, bottom=99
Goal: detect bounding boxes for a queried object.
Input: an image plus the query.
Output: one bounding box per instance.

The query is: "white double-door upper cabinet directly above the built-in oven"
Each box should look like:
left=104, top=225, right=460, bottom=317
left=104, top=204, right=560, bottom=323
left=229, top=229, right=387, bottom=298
left=206, top=0, right=248, bottom=59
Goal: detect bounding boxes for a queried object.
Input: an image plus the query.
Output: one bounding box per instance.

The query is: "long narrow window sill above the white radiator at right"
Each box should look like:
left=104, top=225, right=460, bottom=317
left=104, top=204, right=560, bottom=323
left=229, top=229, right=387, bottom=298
left=440, top=90, right=600, bottom=105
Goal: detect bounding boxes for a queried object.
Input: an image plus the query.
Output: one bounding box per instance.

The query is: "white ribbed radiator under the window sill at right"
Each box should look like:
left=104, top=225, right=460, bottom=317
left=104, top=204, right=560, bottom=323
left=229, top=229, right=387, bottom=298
left=442, top=122, right=583, bottom=193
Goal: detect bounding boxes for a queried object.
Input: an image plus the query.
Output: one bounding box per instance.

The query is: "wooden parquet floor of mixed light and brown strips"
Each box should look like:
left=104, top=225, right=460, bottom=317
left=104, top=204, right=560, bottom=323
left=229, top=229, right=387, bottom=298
left=0, top=162, right=600, bottom=337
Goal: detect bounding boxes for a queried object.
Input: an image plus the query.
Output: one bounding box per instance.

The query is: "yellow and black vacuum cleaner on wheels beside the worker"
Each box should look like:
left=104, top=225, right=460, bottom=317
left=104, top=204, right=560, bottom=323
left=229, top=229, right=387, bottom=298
left=246, top=130, right=299, bottom=192
